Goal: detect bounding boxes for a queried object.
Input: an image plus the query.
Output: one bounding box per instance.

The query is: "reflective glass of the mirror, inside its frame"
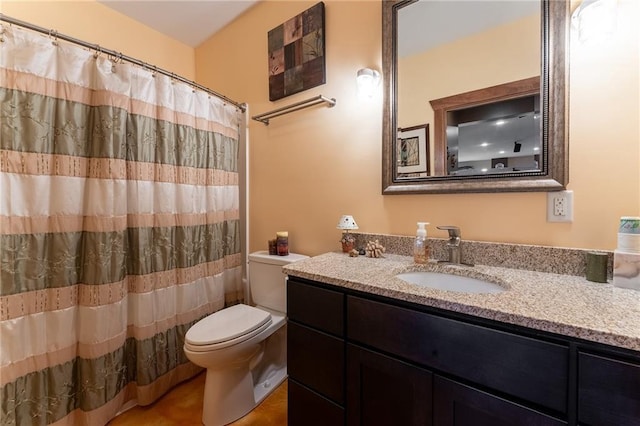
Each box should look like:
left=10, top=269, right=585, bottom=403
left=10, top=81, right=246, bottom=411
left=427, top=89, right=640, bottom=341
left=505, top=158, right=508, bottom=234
left=396, top=0, right=542, bottom=180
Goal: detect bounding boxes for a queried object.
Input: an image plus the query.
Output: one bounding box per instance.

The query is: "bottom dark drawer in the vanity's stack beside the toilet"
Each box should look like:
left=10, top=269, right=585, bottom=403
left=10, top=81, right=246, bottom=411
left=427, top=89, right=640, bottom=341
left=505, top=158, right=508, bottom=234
left=287, top=380, right=344, bottom=426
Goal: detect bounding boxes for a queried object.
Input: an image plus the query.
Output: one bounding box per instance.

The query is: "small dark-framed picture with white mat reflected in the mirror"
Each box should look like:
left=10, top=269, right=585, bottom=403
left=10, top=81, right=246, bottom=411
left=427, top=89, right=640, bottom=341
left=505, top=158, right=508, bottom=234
left=396, top=124, right=429, bottom=179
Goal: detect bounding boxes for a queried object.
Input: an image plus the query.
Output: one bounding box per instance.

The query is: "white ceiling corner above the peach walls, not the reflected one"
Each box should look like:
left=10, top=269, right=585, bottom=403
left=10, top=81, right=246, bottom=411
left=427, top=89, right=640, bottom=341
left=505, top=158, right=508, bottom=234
left=98, top=0, right=259, bottom=47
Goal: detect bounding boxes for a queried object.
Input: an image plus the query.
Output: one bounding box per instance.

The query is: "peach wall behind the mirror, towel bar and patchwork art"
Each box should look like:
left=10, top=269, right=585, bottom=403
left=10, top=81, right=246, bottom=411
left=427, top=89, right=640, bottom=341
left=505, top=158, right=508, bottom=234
left=196, top=0, right=640, bottom=254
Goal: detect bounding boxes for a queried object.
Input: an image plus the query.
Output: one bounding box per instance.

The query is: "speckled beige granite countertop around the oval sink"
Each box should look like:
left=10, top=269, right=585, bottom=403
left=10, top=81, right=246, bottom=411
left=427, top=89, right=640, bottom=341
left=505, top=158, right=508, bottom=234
left=283, top=253, right=640, bottom=351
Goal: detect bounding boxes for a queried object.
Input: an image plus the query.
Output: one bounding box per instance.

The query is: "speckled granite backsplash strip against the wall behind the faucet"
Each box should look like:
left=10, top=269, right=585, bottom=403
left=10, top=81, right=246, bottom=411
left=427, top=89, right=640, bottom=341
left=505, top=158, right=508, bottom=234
left=353, top=232, right=613, bottom=280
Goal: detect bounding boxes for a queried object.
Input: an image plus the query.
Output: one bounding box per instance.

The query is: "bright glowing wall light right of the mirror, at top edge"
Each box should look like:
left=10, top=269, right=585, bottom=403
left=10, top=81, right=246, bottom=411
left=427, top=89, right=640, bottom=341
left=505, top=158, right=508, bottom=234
left=571, top=0, right=617, bottom=43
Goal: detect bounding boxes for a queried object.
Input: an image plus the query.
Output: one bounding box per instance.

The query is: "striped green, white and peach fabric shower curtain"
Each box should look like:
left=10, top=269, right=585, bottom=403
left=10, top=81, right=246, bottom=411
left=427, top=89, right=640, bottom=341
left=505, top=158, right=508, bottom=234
left=0, top=24, right=243, bottom=426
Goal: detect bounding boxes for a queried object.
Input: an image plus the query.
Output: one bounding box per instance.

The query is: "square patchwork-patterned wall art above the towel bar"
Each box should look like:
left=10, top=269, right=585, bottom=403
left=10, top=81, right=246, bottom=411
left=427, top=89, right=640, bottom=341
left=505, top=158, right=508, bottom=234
left=268, top=2, right=325, bottom=101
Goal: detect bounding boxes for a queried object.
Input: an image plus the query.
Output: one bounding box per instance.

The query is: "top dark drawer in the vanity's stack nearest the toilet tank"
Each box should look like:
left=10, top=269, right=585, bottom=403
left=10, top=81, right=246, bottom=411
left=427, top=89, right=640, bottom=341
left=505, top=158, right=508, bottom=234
left=287, top=278, right=344, bottom=336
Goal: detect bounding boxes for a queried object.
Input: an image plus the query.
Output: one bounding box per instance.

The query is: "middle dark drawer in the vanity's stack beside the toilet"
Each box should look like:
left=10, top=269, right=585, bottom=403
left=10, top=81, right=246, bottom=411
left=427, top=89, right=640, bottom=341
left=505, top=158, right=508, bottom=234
left=287, top=322, right=344, bottom=405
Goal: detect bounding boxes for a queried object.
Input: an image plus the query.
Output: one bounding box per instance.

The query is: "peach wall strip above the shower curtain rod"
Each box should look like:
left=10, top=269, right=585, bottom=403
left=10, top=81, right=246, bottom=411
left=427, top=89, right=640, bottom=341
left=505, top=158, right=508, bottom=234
left=0, top=0, right=196, bottom=80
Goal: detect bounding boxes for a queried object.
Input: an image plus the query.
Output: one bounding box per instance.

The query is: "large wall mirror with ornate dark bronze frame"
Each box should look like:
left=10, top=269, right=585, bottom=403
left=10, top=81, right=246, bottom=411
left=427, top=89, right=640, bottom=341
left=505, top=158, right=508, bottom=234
left=382, top=0, right=569, bottom=194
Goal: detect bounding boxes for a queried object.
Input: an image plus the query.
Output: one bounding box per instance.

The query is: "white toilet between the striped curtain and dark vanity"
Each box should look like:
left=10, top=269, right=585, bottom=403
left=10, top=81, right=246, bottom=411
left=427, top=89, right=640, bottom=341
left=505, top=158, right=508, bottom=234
left=184, top=251, right=308, bottom=426
